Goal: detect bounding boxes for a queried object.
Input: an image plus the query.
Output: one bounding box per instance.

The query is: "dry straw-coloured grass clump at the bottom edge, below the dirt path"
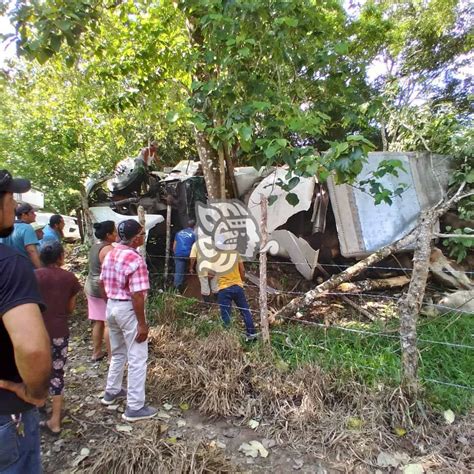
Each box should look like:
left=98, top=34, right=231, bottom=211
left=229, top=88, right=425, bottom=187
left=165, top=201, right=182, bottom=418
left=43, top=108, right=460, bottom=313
left=81, top=423, right=238, bottom=474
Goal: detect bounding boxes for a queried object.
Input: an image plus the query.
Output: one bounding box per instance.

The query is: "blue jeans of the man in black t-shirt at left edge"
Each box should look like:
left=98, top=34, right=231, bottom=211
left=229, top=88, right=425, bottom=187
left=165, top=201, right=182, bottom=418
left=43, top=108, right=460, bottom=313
left=0, top=408, right=42, bottom=474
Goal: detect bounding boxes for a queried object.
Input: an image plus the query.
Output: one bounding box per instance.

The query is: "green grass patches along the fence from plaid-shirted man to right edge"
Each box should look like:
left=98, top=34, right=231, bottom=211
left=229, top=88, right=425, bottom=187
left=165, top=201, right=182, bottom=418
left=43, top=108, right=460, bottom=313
left=148, top=292, right=474, bottom=413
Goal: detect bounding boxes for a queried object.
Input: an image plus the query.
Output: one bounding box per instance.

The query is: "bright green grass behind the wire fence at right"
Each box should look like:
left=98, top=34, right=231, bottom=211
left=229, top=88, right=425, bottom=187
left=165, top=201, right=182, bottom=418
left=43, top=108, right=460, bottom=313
left=272, top=314, right=474, bottom=412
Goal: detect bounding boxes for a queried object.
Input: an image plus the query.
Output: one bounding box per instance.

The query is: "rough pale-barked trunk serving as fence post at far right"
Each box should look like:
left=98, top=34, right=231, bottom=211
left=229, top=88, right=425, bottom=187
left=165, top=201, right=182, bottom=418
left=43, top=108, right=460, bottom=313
left=400, top=209, right=437, bottom=397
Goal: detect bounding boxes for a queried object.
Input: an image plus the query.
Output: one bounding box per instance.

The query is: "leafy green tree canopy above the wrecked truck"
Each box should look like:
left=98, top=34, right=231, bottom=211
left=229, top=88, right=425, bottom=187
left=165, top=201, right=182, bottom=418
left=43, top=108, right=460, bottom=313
left=0, top=0, right=472, bottom=210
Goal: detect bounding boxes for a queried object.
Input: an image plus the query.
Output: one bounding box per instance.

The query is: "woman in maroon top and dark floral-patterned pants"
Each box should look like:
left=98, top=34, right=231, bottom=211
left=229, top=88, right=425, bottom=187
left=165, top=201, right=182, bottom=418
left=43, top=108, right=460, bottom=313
left=35, top=241, right=82, bottom=435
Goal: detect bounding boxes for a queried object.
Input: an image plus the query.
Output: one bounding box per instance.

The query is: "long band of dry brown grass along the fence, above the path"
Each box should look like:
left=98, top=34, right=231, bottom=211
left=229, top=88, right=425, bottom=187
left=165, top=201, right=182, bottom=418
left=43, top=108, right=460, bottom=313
left=145, top=326, right=473, bottom=472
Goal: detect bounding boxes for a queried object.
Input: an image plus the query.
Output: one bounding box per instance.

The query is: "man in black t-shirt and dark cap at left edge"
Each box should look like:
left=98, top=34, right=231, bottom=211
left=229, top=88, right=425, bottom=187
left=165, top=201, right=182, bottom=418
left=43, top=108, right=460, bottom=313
left=0, top=170, right=51, bottom=474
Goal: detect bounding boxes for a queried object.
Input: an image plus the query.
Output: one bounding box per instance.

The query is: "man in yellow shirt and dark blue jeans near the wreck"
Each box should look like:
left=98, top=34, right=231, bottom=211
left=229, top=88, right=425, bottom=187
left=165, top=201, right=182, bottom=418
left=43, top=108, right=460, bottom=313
left=217, top=257, right=256, bottom=339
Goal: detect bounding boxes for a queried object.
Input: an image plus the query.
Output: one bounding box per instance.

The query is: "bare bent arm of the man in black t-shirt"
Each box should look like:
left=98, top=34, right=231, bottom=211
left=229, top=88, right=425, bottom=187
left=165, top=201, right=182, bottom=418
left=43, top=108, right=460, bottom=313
left=0, top=303, right=51, bottom=406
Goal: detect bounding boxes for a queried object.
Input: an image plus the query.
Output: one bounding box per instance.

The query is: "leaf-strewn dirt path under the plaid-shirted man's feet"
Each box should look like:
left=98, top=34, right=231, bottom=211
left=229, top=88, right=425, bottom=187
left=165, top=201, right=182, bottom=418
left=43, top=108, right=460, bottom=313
left=42, top=311, right=336, bottom=474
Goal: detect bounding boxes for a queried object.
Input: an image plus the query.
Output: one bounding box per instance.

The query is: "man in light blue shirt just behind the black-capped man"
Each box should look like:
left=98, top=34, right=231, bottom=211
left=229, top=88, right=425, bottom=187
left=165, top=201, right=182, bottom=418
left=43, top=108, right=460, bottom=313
left=0, top=204, right=41, bottom=268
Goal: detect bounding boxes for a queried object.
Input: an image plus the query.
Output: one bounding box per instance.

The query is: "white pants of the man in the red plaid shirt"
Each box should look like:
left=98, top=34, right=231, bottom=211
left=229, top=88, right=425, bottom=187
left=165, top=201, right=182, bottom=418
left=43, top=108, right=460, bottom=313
left=105, top=300, right=148, bottom=410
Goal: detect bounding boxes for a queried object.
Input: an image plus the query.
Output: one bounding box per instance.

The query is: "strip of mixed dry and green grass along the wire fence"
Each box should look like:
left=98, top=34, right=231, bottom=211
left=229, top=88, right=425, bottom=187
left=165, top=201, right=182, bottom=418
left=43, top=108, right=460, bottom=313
left=143, top=294, right=472, bottom=472
